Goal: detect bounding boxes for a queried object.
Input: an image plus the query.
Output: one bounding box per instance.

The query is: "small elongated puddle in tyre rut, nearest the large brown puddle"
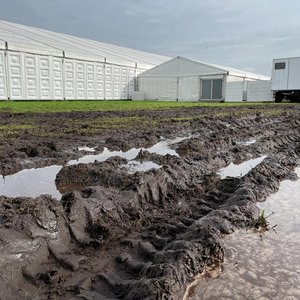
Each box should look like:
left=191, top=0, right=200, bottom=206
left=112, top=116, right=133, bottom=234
left=217, top=155, right=267, bottom=179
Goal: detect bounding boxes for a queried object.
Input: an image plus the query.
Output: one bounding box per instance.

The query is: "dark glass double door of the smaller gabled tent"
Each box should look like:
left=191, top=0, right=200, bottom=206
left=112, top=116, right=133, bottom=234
left=201, top=79, right=224, bottom=100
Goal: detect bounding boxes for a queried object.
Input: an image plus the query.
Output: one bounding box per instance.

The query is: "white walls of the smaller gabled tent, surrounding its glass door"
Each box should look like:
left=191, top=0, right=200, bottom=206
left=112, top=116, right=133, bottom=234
left=138, top=74, right=272, bottom=102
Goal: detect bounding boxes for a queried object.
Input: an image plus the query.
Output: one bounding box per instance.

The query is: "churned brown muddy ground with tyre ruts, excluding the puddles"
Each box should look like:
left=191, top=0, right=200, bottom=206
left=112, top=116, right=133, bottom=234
left=0, top=106, right=300, bottom=300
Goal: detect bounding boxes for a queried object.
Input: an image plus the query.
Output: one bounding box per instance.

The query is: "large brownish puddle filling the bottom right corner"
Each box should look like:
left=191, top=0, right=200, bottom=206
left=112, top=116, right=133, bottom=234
left=185, top=168, right=300, bottom=300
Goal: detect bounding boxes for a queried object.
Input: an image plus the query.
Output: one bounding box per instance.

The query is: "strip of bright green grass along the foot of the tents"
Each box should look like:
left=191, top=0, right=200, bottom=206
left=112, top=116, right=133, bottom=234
left=0, top=100, right=280, bottom=113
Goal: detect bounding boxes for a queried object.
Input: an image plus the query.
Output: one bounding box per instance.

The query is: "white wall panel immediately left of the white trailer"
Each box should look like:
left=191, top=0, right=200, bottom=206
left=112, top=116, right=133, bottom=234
left=247, top=80, right=273, bottom=102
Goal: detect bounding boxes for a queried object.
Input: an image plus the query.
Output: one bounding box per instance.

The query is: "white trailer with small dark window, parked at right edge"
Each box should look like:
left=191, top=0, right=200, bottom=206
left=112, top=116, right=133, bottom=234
left=272, top=57, right=300, bottom=102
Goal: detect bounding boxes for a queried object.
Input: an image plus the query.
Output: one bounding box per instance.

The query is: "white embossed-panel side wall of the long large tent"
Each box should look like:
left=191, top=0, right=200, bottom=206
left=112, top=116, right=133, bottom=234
left=0, top=49, right=149, bottom=100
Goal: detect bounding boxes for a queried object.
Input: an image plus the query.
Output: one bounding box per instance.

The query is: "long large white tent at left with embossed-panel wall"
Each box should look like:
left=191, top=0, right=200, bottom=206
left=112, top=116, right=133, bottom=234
left=0, top=21, right=169, bottom=100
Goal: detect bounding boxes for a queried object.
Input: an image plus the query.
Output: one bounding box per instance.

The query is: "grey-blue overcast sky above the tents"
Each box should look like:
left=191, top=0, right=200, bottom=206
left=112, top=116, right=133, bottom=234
left=0, top=0, right=300, bottom=75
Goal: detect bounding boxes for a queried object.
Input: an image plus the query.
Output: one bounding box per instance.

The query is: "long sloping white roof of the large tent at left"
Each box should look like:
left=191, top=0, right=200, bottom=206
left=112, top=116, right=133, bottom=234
left=0, top=20, right=169, bottom=68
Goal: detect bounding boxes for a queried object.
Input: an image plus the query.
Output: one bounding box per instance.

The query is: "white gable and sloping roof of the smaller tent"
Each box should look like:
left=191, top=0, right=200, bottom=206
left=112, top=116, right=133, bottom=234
left=139, top=56, right=270, bottom=80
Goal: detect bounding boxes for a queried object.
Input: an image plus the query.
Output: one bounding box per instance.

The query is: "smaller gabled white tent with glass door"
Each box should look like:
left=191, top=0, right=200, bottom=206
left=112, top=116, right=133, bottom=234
left=138, top=57, right=272, bottom=101
